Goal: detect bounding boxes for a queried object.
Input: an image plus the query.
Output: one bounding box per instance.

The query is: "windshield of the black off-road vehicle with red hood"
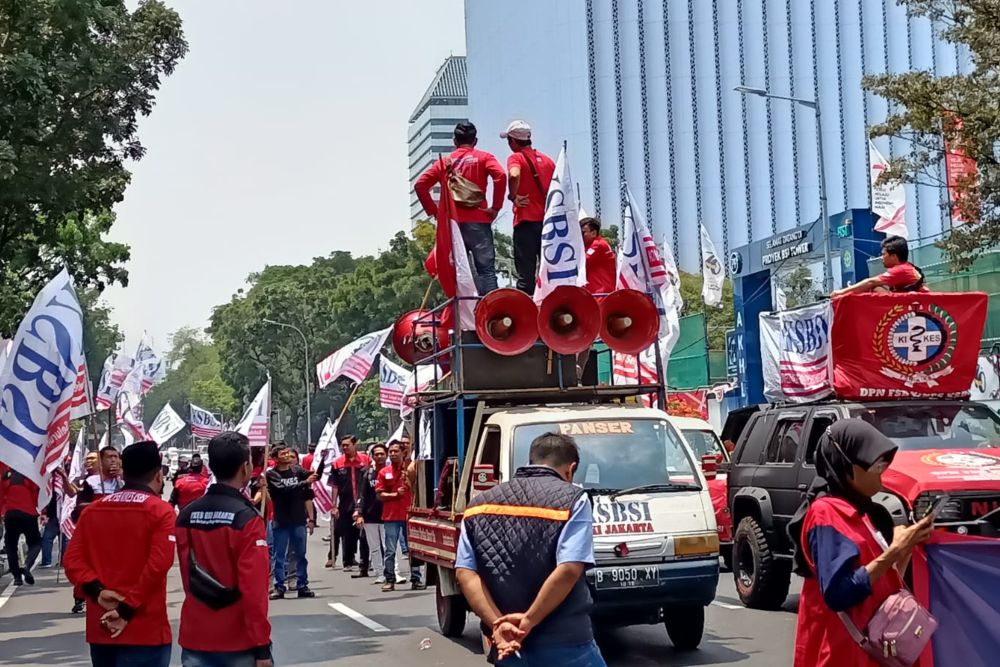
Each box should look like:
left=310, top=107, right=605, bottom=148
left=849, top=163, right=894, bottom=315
left=851, top=403, right=1000, bottom=450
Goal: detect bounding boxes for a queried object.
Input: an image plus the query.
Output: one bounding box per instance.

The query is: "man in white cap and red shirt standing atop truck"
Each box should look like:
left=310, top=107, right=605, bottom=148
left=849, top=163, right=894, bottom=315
left=500, top=120, right=556, bottom=294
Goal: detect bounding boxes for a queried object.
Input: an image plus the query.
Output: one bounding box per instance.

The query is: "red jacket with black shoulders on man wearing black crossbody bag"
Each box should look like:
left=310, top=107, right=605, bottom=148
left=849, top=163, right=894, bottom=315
left=177, top=484, right=271, bottom=660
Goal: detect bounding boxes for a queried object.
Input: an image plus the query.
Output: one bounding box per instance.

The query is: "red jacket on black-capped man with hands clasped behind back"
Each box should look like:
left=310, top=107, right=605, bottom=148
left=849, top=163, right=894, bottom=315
left=63, top=485, right=176, bottom=646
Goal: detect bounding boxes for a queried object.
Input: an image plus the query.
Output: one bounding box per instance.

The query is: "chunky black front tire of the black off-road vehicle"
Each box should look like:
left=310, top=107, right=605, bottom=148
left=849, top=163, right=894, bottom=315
left=732, top=516, right=792, bottom=609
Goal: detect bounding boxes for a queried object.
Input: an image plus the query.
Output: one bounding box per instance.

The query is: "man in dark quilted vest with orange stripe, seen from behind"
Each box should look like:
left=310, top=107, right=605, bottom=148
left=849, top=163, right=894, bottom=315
left=455, top=433, right=605, bottom=667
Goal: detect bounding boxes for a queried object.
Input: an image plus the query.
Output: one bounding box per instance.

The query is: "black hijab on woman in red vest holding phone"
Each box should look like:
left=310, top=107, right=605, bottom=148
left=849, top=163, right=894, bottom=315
left=788, top=419, right=898, bottom=577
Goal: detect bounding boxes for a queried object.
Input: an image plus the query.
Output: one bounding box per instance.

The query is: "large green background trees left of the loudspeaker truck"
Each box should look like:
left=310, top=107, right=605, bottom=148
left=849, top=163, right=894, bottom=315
left=210, top=234, right=442, bottom=442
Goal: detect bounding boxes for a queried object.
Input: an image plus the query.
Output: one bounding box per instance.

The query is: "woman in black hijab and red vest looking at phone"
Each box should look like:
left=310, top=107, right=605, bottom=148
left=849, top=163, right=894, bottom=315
left=788, top=419, right=933, bottom=667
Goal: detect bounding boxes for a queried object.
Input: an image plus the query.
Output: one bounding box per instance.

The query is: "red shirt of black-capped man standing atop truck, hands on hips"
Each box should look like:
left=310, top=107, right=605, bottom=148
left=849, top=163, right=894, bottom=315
left=413, top=146, right=507, bottom=223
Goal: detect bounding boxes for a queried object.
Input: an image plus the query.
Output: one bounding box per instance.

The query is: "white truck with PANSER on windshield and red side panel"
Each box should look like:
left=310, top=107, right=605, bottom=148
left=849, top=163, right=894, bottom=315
left=409, top=402, right=719, bottom=648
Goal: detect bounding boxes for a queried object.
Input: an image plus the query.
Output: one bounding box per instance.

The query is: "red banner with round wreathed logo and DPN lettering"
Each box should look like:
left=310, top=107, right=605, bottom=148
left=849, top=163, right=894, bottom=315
left=830, top=292, right=987, bottom=400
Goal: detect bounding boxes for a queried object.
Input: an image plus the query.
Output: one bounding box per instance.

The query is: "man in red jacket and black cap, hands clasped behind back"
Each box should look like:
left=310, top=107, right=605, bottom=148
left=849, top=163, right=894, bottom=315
left=63, top=440, right=176, bottom=667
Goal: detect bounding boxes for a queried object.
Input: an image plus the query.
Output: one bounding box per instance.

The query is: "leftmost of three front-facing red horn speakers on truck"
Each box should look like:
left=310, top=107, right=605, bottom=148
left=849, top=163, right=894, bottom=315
left=476, top=287, right=538, bottom=357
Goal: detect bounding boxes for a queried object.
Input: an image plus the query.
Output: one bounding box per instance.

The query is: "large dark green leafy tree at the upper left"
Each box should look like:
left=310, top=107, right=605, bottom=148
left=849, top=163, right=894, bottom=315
left=0, top=0, right=187, bottom=331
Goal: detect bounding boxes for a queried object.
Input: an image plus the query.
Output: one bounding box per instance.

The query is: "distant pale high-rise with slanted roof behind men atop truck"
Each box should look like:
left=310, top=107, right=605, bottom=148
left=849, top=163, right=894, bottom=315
left=407, top=56, right=469, bottom=224
